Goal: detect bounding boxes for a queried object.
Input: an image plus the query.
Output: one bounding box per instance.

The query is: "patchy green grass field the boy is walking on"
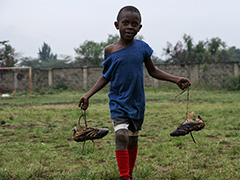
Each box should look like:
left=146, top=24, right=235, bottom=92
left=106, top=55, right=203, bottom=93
left=0, top=87, right=240, bottom=180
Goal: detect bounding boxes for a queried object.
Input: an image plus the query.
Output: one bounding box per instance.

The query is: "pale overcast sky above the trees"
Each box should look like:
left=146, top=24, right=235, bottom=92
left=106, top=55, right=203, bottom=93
left=0, top=0, right=240, bottom=59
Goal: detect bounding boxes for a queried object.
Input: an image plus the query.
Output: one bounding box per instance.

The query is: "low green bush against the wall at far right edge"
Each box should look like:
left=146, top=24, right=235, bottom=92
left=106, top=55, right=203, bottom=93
left=221, top=74, right=240, bottom=91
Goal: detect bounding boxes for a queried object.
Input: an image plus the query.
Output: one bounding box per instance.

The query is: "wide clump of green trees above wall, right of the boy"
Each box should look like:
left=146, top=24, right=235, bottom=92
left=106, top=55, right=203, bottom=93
left=163, top=34, right=233, bottom=64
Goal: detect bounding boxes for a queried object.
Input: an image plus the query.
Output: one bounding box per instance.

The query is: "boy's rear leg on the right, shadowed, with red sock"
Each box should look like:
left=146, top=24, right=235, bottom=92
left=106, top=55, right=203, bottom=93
left=128, top=136, right=138, bottom=176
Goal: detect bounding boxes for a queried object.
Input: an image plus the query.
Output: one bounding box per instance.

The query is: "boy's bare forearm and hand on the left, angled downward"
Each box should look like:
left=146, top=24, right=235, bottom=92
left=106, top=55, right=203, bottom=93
left=78, top=76, right=109, bottom=110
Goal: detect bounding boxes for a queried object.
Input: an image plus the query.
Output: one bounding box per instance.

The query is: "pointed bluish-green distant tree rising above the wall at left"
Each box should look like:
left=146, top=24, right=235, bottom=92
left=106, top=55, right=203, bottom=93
left=38, top=42, right=57, bottom=62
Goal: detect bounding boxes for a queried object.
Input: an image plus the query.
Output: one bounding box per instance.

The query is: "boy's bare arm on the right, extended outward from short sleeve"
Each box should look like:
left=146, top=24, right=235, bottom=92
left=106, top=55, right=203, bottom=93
left=145, top=58, right=191, bottom=90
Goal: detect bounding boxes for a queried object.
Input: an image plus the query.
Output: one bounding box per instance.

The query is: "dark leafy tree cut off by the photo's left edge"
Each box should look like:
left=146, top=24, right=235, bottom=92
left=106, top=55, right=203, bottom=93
left=0, top=41, right=17, bottom=67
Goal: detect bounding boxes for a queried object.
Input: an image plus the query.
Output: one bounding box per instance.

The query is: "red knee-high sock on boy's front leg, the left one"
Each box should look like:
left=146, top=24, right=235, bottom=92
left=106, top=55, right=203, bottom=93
left=116, top=150, right=129, bottom=179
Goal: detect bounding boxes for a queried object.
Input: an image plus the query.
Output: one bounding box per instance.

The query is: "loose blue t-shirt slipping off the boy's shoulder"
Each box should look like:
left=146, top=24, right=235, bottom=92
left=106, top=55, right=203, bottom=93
left=103, top=40, right=153, bottom=119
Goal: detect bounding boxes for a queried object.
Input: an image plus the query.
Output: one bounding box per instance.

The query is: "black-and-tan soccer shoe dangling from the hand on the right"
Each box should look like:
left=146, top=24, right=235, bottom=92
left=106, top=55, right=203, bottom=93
left=170, top=112, right=205, bottom=136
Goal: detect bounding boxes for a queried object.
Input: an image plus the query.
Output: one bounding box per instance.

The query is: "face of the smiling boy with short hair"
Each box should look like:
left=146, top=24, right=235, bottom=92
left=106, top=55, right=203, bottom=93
left=115, top=11, right=142, bottom=41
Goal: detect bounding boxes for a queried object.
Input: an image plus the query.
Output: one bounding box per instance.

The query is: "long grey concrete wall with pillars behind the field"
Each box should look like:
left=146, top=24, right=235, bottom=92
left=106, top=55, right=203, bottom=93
left=0, top=63, right=240, bottom=93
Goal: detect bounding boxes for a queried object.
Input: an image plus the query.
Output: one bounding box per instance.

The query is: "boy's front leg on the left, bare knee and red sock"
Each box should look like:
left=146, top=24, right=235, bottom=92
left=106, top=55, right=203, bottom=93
left=115, top=129, right=130, bottom=179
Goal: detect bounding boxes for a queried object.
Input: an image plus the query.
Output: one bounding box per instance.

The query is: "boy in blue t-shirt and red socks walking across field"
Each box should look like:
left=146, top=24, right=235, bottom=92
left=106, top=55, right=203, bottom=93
left=79, top=6, right=191, bottom=180
